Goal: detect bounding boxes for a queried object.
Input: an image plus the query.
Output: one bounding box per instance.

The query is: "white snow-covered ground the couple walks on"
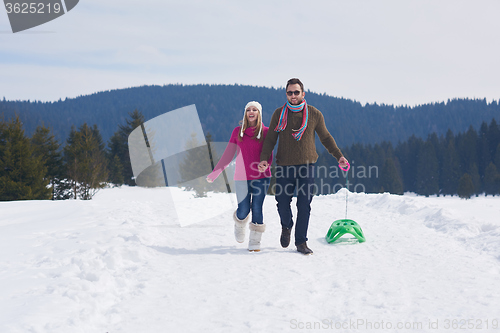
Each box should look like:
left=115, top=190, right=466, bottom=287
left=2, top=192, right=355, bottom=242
left=0, top=187, right=500, bottom=333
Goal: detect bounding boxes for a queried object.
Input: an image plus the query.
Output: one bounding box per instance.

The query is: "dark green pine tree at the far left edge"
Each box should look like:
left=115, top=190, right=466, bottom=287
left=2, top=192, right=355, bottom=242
left=0, top=116, right=51, bottom=201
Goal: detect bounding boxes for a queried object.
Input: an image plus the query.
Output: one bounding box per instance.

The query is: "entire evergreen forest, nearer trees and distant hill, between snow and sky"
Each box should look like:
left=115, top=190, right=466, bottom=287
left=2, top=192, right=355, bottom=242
left=0, top=85, right=500, bottom=201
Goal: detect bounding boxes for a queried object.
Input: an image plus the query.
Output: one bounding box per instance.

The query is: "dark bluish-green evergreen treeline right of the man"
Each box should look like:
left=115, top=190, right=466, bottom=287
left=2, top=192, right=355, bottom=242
left=317, top=119, right=500, bottom=198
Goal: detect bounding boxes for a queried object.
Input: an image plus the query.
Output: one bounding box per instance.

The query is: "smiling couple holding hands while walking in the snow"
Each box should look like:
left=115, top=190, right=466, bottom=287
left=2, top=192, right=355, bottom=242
left=207, top=78, right=348, bottom=254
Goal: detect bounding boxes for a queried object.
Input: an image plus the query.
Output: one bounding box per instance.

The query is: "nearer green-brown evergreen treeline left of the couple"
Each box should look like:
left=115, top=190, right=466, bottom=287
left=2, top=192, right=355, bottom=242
left=0, top=110, right=144, bottom=201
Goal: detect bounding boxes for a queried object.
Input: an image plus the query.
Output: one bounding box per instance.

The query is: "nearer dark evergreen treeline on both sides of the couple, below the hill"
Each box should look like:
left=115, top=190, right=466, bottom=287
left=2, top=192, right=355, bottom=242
left=0, top=110, right=500, bottom=201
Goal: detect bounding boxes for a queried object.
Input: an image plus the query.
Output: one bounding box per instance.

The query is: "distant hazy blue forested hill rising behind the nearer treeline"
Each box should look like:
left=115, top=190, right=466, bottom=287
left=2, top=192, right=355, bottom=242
left=0, top=84, right=500, bottom=147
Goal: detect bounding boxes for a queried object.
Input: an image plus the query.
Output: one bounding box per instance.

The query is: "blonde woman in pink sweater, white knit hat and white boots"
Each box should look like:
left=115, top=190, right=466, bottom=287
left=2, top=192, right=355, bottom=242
left=207, top=101, right=273, bottom=252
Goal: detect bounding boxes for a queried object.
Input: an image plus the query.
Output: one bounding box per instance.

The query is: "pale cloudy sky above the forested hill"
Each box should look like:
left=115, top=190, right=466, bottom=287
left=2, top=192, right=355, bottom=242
left=0, top=0, right=500, bottom=106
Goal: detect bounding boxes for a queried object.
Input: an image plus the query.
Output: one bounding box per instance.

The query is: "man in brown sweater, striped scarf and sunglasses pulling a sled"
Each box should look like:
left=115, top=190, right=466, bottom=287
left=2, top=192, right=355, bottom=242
left=258, top=78, right=348, bottom=254
